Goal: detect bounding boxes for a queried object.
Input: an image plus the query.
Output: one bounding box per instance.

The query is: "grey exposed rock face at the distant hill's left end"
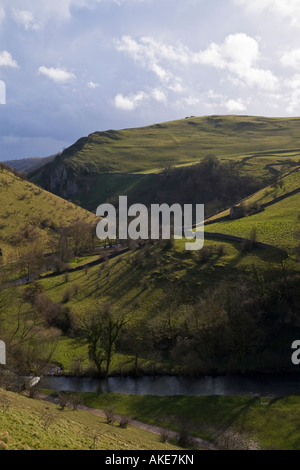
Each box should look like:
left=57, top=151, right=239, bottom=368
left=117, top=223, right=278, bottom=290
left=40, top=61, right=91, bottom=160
left=48, top=163, right=79, bottom=198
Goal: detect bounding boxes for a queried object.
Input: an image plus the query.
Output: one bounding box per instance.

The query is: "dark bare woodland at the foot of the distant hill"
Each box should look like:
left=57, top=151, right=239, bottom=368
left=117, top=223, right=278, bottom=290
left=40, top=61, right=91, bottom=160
left=128, top=154, right=262, bottom=217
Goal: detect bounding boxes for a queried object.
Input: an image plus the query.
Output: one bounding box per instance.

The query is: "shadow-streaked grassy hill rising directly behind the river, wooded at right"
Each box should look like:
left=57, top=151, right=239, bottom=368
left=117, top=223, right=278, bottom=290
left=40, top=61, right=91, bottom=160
left=8, top=235, right=300, bottom=374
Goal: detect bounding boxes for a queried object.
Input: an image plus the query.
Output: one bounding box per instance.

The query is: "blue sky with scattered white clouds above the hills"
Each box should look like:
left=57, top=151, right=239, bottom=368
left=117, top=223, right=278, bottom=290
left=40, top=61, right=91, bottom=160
left=0, top=0, right=300, bottom=161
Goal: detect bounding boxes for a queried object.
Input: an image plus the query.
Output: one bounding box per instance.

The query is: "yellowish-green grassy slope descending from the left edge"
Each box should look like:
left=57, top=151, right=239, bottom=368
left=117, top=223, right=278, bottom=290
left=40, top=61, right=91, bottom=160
left=0, top=170, right=96, bottom=262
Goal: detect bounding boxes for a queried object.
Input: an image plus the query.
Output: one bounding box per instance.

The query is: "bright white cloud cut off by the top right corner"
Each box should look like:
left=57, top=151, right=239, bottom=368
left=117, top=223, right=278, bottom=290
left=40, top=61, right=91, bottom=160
left=234, top=0, right=300, bottom=27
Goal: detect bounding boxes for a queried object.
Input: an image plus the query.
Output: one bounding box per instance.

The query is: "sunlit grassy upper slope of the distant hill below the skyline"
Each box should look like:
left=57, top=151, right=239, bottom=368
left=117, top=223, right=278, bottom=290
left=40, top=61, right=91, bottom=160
left=48, top=116, right=300, bottom=173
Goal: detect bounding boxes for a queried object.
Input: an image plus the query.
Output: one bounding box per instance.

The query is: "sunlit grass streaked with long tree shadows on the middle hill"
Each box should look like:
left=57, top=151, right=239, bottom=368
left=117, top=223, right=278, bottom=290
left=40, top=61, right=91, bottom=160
left=34, top=235, right=297, bottom=373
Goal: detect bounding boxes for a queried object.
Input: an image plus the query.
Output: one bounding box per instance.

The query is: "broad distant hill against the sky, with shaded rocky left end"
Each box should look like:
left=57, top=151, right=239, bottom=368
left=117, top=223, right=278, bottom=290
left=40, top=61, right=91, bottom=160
left=31, top=116, right=300, bottom=211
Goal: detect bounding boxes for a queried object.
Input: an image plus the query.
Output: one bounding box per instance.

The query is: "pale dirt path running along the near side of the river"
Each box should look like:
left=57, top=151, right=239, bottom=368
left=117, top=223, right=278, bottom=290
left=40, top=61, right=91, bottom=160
left=36, top=393, right=218, bottom=450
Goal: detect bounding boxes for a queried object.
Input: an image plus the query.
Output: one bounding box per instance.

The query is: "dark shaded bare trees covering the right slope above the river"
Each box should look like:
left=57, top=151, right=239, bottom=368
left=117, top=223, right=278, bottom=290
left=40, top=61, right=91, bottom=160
left=117, top=269, right=300, bottom=375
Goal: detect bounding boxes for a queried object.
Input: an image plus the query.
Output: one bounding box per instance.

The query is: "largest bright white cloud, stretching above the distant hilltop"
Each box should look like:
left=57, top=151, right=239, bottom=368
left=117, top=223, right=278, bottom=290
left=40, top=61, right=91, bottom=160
left=116, top=33, right=278, bottom=91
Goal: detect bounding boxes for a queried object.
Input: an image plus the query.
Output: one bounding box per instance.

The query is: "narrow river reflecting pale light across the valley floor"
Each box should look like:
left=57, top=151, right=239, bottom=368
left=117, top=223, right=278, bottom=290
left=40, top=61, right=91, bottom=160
left=40, top=375, right=300, bottom=397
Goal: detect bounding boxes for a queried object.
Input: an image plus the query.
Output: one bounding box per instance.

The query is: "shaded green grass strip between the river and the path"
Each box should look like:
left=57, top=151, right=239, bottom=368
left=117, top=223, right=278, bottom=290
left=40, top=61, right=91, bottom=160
left=81, top=393, right=300, bottom=450
